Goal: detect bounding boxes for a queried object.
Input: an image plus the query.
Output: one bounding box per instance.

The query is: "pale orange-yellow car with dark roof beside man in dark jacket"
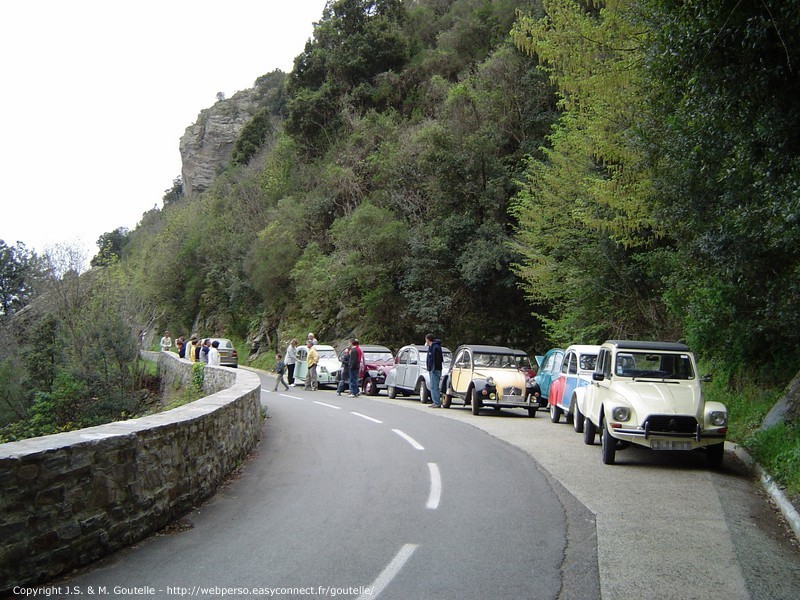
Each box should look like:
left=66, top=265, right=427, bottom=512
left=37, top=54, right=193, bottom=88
left=443, top=344, right=538, bottom=417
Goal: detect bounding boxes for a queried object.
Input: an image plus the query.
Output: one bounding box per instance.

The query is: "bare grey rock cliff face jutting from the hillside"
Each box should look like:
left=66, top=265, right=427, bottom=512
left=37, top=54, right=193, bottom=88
left=180, top=89, right=259, bottom=195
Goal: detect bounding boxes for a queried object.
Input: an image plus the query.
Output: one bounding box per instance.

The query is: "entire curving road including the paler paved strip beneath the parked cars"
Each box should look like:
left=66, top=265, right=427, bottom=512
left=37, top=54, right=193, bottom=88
left=32, top=368, right=800, bottom=600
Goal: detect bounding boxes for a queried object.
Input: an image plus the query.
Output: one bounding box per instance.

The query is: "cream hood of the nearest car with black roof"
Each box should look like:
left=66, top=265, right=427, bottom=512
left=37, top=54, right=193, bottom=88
left=612, top=381, right=702, bottom=417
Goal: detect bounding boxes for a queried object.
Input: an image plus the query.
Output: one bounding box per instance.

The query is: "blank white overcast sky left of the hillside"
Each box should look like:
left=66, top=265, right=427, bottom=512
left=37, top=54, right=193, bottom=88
left=0, top=0, right=325, bottom=260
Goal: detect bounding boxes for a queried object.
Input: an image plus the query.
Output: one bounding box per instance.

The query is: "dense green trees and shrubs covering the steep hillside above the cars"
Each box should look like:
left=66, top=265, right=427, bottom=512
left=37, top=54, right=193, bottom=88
left=4, top=0, right=800, bottom=492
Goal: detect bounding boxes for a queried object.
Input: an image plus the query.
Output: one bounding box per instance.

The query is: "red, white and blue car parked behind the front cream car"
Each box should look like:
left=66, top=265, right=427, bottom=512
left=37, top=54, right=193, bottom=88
left=547, top=344, right=600, bottom=433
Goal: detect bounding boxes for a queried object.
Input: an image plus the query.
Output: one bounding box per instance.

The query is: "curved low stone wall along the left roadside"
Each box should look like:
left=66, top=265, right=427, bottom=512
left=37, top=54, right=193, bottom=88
left=0, top=353, right=262, bottom=595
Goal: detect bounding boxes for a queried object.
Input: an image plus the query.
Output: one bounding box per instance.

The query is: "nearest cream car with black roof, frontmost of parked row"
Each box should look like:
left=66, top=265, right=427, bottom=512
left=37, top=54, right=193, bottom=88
left=583, top=340, right=728, bottom=468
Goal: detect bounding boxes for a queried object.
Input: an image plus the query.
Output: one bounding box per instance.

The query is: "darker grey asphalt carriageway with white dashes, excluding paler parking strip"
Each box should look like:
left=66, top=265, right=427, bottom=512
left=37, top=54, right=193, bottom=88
left=43, top=375, right=599, bottom=600
